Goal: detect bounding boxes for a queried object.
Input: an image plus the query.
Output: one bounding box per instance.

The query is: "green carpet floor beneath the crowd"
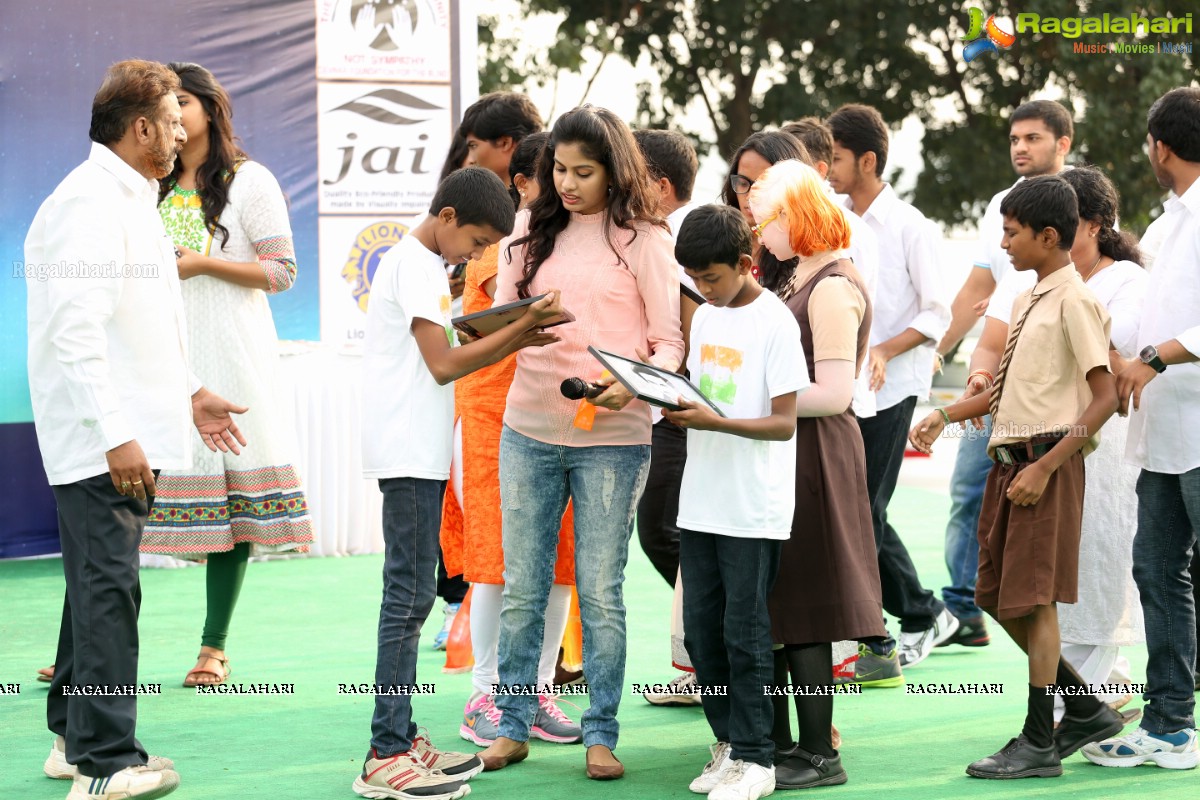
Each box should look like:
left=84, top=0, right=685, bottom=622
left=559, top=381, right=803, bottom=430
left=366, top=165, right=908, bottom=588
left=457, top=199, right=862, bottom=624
left=0, top=488, right=1180, bottom=800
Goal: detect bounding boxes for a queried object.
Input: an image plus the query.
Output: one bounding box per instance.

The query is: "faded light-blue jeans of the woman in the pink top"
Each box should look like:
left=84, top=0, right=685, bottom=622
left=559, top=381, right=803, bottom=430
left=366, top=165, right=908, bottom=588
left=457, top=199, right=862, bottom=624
left=496, top=426, right=650, bottom=750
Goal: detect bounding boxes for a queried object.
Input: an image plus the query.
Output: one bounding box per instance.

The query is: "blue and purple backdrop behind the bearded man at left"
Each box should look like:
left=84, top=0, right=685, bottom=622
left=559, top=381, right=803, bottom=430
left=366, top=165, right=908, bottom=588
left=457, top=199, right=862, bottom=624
left=0, top=0, right=319, bottom=558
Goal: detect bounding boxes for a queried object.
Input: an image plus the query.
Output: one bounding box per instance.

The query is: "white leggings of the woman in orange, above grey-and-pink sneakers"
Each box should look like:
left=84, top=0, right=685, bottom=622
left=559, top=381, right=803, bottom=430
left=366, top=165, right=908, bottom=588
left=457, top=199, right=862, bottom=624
left=470, top=583, right=571, bottom=698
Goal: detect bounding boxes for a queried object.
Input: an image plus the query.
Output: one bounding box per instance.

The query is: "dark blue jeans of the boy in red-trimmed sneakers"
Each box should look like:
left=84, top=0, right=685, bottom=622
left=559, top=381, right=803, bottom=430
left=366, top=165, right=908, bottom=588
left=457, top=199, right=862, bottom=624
left=371, top=477, right=446, bottom=757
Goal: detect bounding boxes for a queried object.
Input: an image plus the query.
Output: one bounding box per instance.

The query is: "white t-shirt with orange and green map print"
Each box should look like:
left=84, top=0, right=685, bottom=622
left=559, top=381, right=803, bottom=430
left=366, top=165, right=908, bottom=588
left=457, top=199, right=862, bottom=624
left=678, top=291, right=809, bottom=539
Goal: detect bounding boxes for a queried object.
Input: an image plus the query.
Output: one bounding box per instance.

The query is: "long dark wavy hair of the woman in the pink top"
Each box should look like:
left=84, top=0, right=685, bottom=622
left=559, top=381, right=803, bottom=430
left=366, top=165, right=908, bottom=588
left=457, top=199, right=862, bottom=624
left=512, top=106, right=666, bottom=297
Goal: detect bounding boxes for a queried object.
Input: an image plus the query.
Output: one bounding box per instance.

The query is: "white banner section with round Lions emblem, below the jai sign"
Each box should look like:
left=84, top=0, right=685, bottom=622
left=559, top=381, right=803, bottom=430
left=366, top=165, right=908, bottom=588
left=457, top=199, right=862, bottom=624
left=319, top=216, right=420, bottom=344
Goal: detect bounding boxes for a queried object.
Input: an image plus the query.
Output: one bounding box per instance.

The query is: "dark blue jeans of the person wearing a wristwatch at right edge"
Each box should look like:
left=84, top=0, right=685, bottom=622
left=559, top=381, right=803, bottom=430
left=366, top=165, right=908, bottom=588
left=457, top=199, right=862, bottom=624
left=1118, top=468, right=1200, bottom=733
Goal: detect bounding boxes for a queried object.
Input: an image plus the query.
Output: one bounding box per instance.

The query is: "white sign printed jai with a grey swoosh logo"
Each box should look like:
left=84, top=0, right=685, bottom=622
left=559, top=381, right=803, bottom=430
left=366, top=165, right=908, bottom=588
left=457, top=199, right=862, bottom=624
left=317, top=83, right=452, bottom=213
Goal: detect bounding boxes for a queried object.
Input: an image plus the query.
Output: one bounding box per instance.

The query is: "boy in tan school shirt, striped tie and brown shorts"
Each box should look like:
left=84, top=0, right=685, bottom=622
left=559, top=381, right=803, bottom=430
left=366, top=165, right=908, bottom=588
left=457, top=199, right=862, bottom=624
left=910, top=176, right=1122, bottom=778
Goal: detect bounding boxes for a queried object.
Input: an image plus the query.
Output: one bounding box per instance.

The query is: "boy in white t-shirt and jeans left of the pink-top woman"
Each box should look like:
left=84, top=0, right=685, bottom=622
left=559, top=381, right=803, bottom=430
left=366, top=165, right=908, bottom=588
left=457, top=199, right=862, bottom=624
left=354, top=167, right=562, bottom=800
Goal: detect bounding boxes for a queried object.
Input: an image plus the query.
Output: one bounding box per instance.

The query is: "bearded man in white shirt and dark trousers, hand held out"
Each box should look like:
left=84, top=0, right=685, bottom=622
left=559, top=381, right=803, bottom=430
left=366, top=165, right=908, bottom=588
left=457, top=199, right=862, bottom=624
left=25, top=61, right=246, bottom=800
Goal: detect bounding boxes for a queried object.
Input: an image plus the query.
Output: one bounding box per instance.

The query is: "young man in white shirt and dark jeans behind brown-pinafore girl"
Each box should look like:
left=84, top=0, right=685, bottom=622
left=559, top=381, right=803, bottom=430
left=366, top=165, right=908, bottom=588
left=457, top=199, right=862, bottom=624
left=826, top=104, right=959, bottom=682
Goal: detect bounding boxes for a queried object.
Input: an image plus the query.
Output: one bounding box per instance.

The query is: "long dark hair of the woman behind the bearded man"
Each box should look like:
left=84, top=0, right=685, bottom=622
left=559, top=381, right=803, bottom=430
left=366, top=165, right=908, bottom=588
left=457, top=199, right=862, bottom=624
left=158, top=61, right=246, bottom=245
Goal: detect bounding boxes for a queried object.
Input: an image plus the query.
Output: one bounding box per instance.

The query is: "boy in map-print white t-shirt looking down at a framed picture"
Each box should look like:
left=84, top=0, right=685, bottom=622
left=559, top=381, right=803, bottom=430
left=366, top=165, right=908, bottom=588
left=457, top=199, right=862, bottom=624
left=666, top=205, right=809, bottom=800
